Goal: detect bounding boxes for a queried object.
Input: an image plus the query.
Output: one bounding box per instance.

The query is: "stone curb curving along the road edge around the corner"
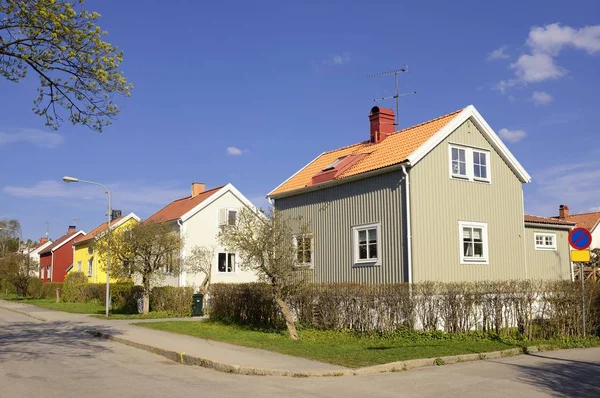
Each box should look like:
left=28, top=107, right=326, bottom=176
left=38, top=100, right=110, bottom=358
left=86, top=330, right=555, bottom=378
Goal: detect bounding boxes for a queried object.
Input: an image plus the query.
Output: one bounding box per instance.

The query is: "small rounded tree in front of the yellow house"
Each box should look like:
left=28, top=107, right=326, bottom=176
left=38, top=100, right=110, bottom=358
left=94, top=222, right=184, bottom=314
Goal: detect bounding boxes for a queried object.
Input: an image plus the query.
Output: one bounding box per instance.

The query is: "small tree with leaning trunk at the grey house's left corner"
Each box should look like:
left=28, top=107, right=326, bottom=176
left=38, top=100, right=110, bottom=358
left=219, top=209, right=308, bottom=340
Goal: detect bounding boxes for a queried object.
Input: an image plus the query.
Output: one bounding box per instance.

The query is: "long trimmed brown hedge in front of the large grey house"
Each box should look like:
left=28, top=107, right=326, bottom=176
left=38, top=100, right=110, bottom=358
left=210, top=281, right=600, bottom=339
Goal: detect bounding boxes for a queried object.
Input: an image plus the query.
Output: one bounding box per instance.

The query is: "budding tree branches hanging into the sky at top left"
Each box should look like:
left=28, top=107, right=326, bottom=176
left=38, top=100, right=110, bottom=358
left=0, top=0, right=132, bottom=131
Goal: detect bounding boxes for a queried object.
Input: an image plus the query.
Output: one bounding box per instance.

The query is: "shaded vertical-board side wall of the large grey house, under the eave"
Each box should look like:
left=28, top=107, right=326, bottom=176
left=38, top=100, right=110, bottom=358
left=275, top=171, right=406, bottom=284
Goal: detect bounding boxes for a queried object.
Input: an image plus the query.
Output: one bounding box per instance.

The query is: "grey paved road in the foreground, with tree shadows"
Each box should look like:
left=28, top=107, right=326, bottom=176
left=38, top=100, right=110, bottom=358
left=0, top=309, right=600, bottom=398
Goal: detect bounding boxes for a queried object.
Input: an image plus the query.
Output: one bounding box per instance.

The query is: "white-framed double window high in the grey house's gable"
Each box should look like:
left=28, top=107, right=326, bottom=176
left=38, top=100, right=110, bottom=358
left=450, top=145, right=491, bottom=182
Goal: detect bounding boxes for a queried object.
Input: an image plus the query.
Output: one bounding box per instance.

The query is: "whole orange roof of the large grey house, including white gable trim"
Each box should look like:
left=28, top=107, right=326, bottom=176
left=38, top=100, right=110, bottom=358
left=269, top=105, right=531, bottom=197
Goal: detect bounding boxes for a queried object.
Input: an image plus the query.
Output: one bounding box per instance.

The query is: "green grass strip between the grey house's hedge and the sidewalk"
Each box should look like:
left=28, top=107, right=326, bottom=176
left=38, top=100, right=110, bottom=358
left=138, top=321, right=600, bottom=368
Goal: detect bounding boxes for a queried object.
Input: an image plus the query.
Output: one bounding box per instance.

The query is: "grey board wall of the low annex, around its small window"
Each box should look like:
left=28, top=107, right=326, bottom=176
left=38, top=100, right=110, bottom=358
left=525, top=226, right=571, bottom=279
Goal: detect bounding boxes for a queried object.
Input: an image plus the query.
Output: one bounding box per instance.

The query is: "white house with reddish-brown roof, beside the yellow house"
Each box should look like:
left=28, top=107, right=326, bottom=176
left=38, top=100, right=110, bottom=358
left=146, top=183, right=257, bottom=287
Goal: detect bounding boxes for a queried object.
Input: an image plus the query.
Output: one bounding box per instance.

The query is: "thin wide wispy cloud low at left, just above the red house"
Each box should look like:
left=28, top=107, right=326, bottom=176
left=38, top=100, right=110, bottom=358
left=3, top=180, right=190, bottom=212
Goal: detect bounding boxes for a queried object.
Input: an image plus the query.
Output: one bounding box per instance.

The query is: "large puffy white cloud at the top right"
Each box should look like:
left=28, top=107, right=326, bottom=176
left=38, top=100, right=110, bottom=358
left=490, top=23, right=600, bottom=92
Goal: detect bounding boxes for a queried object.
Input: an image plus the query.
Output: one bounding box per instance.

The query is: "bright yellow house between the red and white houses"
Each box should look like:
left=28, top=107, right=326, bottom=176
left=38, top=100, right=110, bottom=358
left=67, top=213, right=140, bottom=283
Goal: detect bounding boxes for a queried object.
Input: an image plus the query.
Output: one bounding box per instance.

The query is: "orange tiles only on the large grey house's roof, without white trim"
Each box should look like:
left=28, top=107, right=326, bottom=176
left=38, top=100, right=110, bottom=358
left=271, top=109, right=462, bottom=195
